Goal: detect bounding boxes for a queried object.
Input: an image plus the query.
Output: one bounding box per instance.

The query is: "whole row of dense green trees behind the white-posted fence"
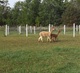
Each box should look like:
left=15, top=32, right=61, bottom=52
left=0, top=0, right=80, bottom=26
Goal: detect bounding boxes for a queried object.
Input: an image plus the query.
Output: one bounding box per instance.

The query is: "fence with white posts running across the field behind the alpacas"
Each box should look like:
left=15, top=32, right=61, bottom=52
left=0, top=24, right=80, bottom=37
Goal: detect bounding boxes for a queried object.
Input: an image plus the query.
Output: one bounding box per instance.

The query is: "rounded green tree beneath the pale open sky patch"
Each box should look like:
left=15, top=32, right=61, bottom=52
left=11, top=1, right=24, bottom=25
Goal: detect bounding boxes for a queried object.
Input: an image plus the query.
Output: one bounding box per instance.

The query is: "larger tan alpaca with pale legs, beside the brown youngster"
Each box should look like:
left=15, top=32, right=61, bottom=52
left=38, top=27, right=54, bottom=42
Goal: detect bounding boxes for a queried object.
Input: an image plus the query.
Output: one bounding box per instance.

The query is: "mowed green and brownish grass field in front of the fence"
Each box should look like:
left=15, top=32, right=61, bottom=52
left=0, top=34, right=80, bottom=73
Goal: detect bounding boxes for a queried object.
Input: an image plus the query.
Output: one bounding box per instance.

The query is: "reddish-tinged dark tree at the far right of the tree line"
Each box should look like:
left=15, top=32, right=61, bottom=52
left=62, top=0, right=80, bottom=26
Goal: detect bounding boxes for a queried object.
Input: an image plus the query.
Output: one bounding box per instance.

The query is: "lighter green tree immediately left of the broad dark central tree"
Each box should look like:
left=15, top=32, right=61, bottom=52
left=25, top=0, right=40, bottom=25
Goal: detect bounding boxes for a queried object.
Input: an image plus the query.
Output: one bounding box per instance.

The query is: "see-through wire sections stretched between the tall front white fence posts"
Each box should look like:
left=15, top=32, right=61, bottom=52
left=0, top=26, right=80, bottom=36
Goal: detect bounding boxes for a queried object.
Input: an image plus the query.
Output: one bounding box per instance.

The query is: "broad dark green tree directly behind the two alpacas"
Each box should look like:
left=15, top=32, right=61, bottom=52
left=39, top=0, right=64, bottom=26
